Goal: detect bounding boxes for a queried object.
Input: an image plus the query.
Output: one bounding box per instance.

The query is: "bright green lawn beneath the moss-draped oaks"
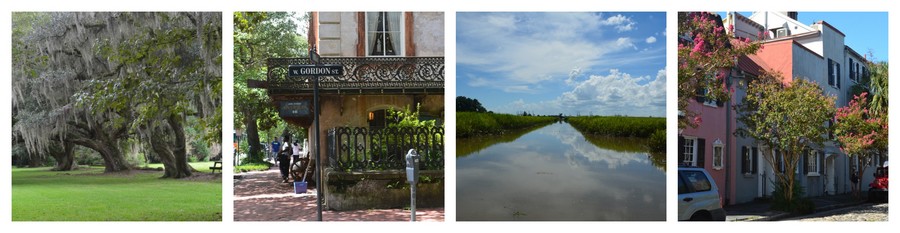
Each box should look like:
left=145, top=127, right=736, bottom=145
left=12, top=163, right=222, bottom=221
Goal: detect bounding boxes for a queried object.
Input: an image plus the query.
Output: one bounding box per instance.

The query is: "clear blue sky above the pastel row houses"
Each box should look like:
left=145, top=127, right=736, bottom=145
left=719, top=11, right=888, bottom=61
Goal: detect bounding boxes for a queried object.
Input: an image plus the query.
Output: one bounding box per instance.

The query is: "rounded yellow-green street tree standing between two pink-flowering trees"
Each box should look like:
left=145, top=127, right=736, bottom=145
left=736, top=71, right=835, bottom=208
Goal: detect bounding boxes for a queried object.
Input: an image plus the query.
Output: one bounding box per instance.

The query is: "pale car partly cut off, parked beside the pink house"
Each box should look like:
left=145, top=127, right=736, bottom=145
left=678, top=167, right=725, bottom=221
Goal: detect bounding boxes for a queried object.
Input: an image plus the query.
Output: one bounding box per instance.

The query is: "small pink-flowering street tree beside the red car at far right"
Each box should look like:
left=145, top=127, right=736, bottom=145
left=834, top=92, right=888, bottom=197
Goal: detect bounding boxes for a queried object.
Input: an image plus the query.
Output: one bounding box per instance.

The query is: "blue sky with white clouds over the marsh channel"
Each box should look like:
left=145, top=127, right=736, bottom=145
left=456, top=12, right=666, bottom=116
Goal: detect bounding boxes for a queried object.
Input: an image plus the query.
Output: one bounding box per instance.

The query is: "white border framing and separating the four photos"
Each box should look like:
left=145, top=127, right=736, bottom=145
left=0, top=0, right=900, bottom=232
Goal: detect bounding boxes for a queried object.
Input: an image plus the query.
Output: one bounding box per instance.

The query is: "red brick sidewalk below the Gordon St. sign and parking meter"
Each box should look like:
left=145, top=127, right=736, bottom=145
left=234, top=169, right=444, bottom=222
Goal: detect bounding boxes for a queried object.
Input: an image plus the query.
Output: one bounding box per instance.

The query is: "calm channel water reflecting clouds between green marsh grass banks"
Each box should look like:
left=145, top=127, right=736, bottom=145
left=456, top=123, right=666, bottom=221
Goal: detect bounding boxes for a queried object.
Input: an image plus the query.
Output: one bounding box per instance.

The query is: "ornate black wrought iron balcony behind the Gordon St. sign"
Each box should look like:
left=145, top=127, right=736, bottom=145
left=266, top=57, right=444, bottom=95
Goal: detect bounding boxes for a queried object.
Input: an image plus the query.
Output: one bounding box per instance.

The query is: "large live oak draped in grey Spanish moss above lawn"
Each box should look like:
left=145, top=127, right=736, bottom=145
left=13, top=12, right=222, bottom=178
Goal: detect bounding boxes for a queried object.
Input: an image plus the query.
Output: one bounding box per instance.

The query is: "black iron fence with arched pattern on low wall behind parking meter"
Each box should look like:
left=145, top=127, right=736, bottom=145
left=327, top=127, right=444, bottom=171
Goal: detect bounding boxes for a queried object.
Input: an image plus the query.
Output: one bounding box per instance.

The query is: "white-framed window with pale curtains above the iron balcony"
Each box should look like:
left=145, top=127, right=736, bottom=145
left=366, top=12, right=404, bottom=56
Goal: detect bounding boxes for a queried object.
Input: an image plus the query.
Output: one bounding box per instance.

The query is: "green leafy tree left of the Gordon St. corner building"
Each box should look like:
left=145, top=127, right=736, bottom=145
left=234, top=12, right=308, bottom=162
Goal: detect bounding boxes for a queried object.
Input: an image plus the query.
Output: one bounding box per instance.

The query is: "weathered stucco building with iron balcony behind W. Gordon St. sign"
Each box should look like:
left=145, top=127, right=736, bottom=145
left=266, top=12, right=444, bottom=210
